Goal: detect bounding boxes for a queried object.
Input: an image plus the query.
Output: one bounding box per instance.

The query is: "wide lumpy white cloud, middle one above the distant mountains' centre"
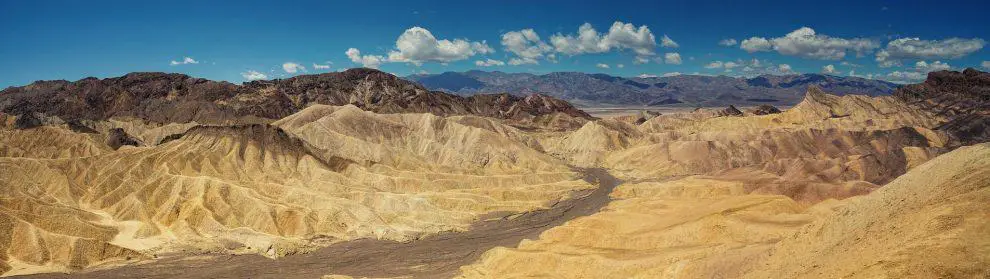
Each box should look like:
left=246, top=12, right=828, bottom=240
left=550, top=21, right=657, bottom=56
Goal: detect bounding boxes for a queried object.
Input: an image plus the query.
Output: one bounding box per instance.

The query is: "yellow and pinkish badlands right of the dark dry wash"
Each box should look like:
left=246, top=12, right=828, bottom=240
left=459, top=88, right=990, bottom=278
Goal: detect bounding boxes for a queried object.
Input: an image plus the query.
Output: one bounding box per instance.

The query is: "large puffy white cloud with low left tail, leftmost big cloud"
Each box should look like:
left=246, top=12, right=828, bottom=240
left=346, top=26, right=495, bottom=68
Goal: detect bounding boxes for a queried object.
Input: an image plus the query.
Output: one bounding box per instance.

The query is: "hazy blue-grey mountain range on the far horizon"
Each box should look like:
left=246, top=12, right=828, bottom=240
left=406, top=71, right=898, bottom=106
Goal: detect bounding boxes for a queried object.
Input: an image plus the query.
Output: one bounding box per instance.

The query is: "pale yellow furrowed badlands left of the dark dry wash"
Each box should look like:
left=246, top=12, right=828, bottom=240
left=0, top=106, right=593, bottom=275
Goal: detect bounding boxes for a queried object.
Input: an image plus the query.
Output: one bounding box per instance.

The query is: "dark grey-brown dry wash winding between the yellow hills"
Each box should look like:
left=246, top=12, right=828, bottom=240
left=18, top=169, right=620, bottom=278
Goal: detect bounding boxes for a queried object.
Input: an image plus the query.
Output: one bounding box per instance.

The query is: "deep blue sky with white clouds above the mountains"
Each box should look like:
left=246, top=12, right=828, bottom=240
left=0, top=0, right=990, bottom=88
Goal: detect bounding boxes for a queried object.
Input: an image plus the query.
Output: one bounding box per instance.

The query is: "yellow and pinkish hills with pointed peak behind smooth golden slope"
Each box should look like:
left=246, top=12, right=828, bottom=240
left=540, top=87, right=948, bottom=203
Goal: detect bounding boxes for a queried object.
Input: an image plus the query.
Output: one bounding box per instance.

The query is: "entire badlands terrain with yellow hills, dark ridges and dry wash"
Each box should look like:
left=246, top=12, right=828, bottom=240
left=0, top=69, right=990, bottom=278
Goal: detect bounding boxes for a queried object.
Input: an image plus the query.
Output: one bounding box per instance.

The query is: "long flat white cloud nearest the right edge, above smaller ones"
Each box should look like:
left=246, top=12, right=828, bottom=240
left=876, top=38, right=986, bottom=67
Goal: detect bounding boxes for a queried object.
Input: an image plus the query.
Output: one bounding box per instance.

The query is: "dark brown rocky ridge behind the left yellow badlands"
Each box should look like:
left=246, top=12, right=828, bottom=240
left=0, top=68, right=590, bottom=126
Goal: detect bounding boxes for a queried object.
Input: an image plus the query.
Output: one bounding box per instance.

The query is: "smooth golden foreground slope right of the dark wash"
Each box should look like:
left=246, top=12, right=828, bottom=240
left=460, top=144, right=990, bottom=278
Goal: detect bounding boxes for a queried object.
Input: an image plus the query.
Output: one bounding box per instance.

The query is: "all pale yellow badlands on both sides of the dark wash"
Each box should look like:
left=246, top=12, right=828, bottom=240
left=0, top=88, right=990, bottom=278
